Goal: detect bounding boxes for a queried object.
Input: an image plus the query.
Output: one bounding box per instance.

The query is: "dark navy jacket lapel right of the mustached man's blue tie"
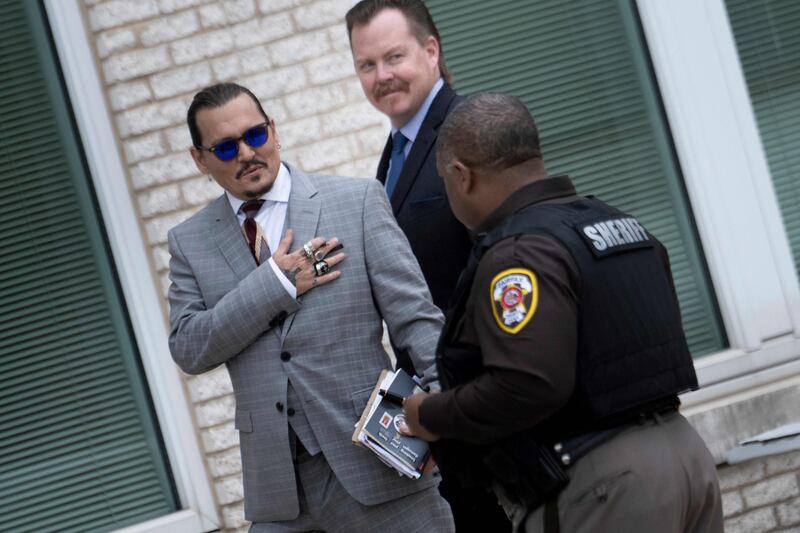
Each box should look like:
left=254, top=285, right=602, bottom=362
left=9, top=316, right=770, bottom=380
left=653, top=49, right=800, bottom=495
left=384, top=83, right=456, bottom=215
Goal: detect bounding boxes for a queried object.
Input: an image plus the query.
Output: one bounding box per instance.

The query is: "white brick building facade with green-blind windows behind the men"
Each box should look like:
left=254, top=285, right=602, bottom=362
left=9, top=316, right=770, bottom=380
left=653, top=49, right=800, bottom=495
left=0, top=0, right=800, bottom=533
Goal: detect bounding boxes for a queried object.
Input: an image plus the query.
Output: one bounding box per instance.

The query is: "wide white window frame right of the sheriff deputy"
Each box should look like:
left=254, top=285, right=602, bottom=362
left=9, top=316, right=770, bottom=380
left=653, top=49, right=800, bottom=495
left=636, top=0, right=800, bottom=408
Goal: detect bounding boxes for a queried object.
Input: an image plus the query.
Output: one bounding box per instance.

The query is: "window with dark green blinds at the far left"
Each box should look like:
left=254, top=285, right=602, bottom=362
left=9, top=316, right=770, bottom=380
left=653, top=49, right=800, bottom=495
left=0, top=0, right=176, bottom=531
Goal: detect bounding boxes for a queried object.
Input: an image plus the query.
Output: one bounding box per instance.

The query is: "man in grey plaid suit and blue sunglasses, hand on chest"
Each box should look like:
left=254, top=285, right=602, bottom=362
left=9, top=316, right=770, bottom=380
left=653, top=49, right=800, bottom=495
left=169, top=84, right=453, bottom=533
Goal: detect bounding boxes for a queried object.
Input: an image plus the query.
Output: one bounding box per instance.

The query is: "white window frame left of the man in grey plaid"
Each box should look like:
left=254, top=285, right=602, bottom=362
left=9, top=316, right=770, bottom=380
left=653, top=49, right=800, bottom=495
left=44, top=0, right=221, bottom=533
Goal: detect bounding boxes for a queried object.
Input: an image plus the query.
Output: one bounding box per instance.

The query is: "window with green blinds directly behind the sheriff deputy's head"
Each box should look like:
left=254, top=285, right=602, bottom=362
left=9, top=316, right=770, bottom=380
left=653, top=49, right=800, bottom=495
left=427, top=0, right=727, bottom=356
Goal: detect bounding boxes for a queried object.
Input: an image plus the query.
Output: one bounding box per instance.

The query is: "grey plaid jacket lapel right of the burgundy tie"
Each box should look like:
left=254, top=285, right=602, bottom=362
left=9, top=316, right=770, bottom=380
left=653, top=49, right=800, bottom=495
left=280, top=163, right=320, bottom=342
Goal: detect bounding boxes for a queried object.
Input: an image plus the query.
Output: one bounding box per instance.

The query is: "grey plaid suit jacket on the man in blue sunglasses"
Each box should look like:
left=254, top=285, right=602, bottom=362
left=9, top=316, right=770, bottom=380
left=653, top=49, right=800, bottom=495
left=169, top=165, right=443, bottom=522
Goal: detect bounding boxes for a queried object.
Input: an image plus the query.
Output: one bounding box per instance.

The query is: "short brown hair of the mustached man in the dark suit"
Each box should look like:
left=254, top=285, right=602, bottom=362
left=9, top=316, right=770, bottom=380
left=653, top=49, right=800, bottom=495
left=344, top=0, right=453, bottom=84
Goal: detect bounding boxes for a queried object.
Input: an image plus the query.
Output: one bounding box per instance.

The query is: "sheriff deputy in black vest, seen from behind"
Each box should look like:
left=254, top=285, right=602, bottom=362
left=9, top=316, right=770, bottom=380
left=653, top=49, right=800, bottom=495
left=405, top=93, right=723, bottom=533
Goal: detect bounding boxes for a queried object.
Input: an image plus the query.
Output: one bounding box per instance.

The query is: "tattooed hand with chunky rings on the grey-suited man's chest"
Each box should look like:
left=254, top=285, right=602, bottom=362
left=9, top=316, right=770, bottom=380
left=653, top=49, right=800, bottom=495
left=272, top=229, right=347, bottom=296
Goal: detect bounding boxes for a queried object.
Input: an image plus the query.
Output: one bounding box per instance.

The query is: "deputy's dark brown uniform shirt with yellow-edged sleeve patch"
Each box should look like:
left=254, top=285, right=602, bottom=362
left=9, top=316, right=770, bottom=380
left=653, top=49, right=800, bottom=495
left=420, top=176, right=668, bottom=444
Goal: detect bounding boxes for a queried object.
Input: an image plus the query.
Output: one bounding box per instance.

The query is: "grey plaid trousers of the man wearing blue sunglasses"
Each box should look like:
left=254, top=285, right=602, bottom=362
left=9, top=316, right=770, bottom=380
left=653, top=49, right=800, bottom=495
left=249, top=453, right=455, bottom=533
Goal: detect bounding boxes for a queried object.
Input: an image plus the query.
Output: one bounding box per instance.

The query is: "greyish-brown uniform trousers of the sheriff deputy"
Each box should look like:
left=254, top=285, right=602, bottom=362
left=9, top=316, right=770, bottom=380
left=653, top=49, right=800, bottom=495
left=504, top=412, right=723, bottom=533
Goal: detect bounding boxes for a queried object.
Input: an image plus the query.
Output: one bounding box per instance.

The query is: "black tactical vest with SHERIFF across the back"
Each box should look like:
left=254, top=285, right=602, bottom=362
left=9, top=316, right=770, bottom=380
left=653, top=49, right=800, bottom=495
left=437, top=197, right=697, bottom=442
